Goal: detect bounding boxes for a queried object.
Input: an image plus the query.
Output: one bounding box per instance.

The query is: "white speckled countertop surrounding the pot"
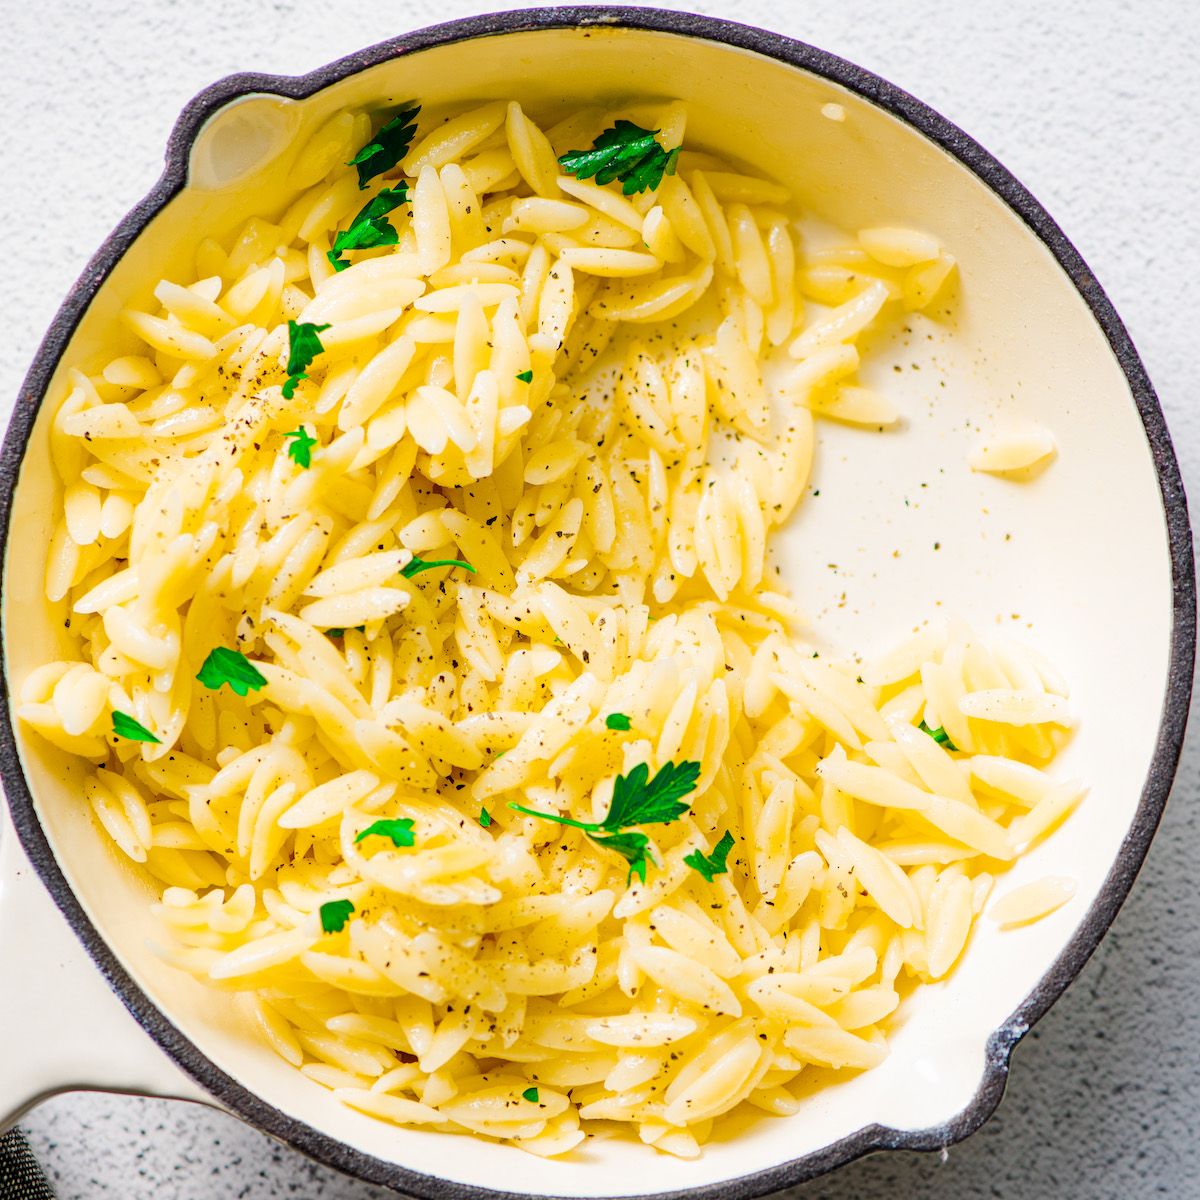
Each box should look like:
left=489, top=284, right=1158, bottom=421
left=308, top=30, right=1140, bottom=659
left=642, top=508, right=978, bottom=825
left=0, top=0, right=1200, bottom=1200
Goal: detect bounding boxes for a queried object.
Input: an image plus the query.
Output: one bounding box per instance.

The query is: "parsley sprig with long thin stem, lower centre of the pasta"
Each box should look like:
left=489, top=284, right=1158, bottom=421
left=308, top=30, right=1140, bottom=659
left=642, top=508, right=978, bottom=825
left=509, top=762, right=700, bottom=883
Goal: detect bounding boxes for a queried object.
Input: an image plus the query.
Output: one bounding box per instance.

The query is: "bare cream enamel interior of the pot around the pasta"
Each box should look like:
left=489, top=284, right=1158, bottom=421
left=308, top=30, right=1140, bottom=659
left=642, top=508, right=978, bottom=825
left=5, top=21, right=1171, bottom=1196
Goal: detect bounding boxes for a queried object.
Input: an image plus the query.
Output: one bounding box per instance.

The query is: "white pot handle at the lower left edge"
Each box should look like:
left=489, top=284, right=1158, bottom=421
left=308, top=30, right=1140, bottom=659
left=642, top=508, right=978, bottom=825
left=0, top=799, right=212, bottom=1134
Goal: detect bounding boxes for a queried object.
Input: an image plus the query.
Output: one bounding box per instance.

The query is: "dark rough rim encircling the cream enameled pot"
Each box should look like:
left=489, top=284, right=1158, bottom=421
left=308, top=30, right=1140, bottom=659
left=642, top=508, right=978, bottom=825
left=0, top=6, right=1195, bottom=1200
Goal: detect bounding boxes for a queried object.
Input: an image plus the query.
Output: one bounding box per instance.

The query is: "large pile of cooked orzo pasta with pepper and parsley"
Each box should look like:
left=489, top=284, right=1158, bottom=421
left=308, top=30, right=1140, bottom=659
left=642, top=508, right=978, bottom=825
left=19, top=101, right=1082, bottom=1156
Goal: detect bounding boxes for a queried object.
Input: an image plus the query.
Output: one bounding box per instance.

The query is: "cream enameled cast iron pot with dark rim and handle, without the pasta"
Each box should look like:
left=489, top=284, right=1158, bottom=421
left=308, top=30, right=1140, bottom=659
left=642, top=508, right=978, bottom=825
left=0, top=8, right=1194, bottom=1200
